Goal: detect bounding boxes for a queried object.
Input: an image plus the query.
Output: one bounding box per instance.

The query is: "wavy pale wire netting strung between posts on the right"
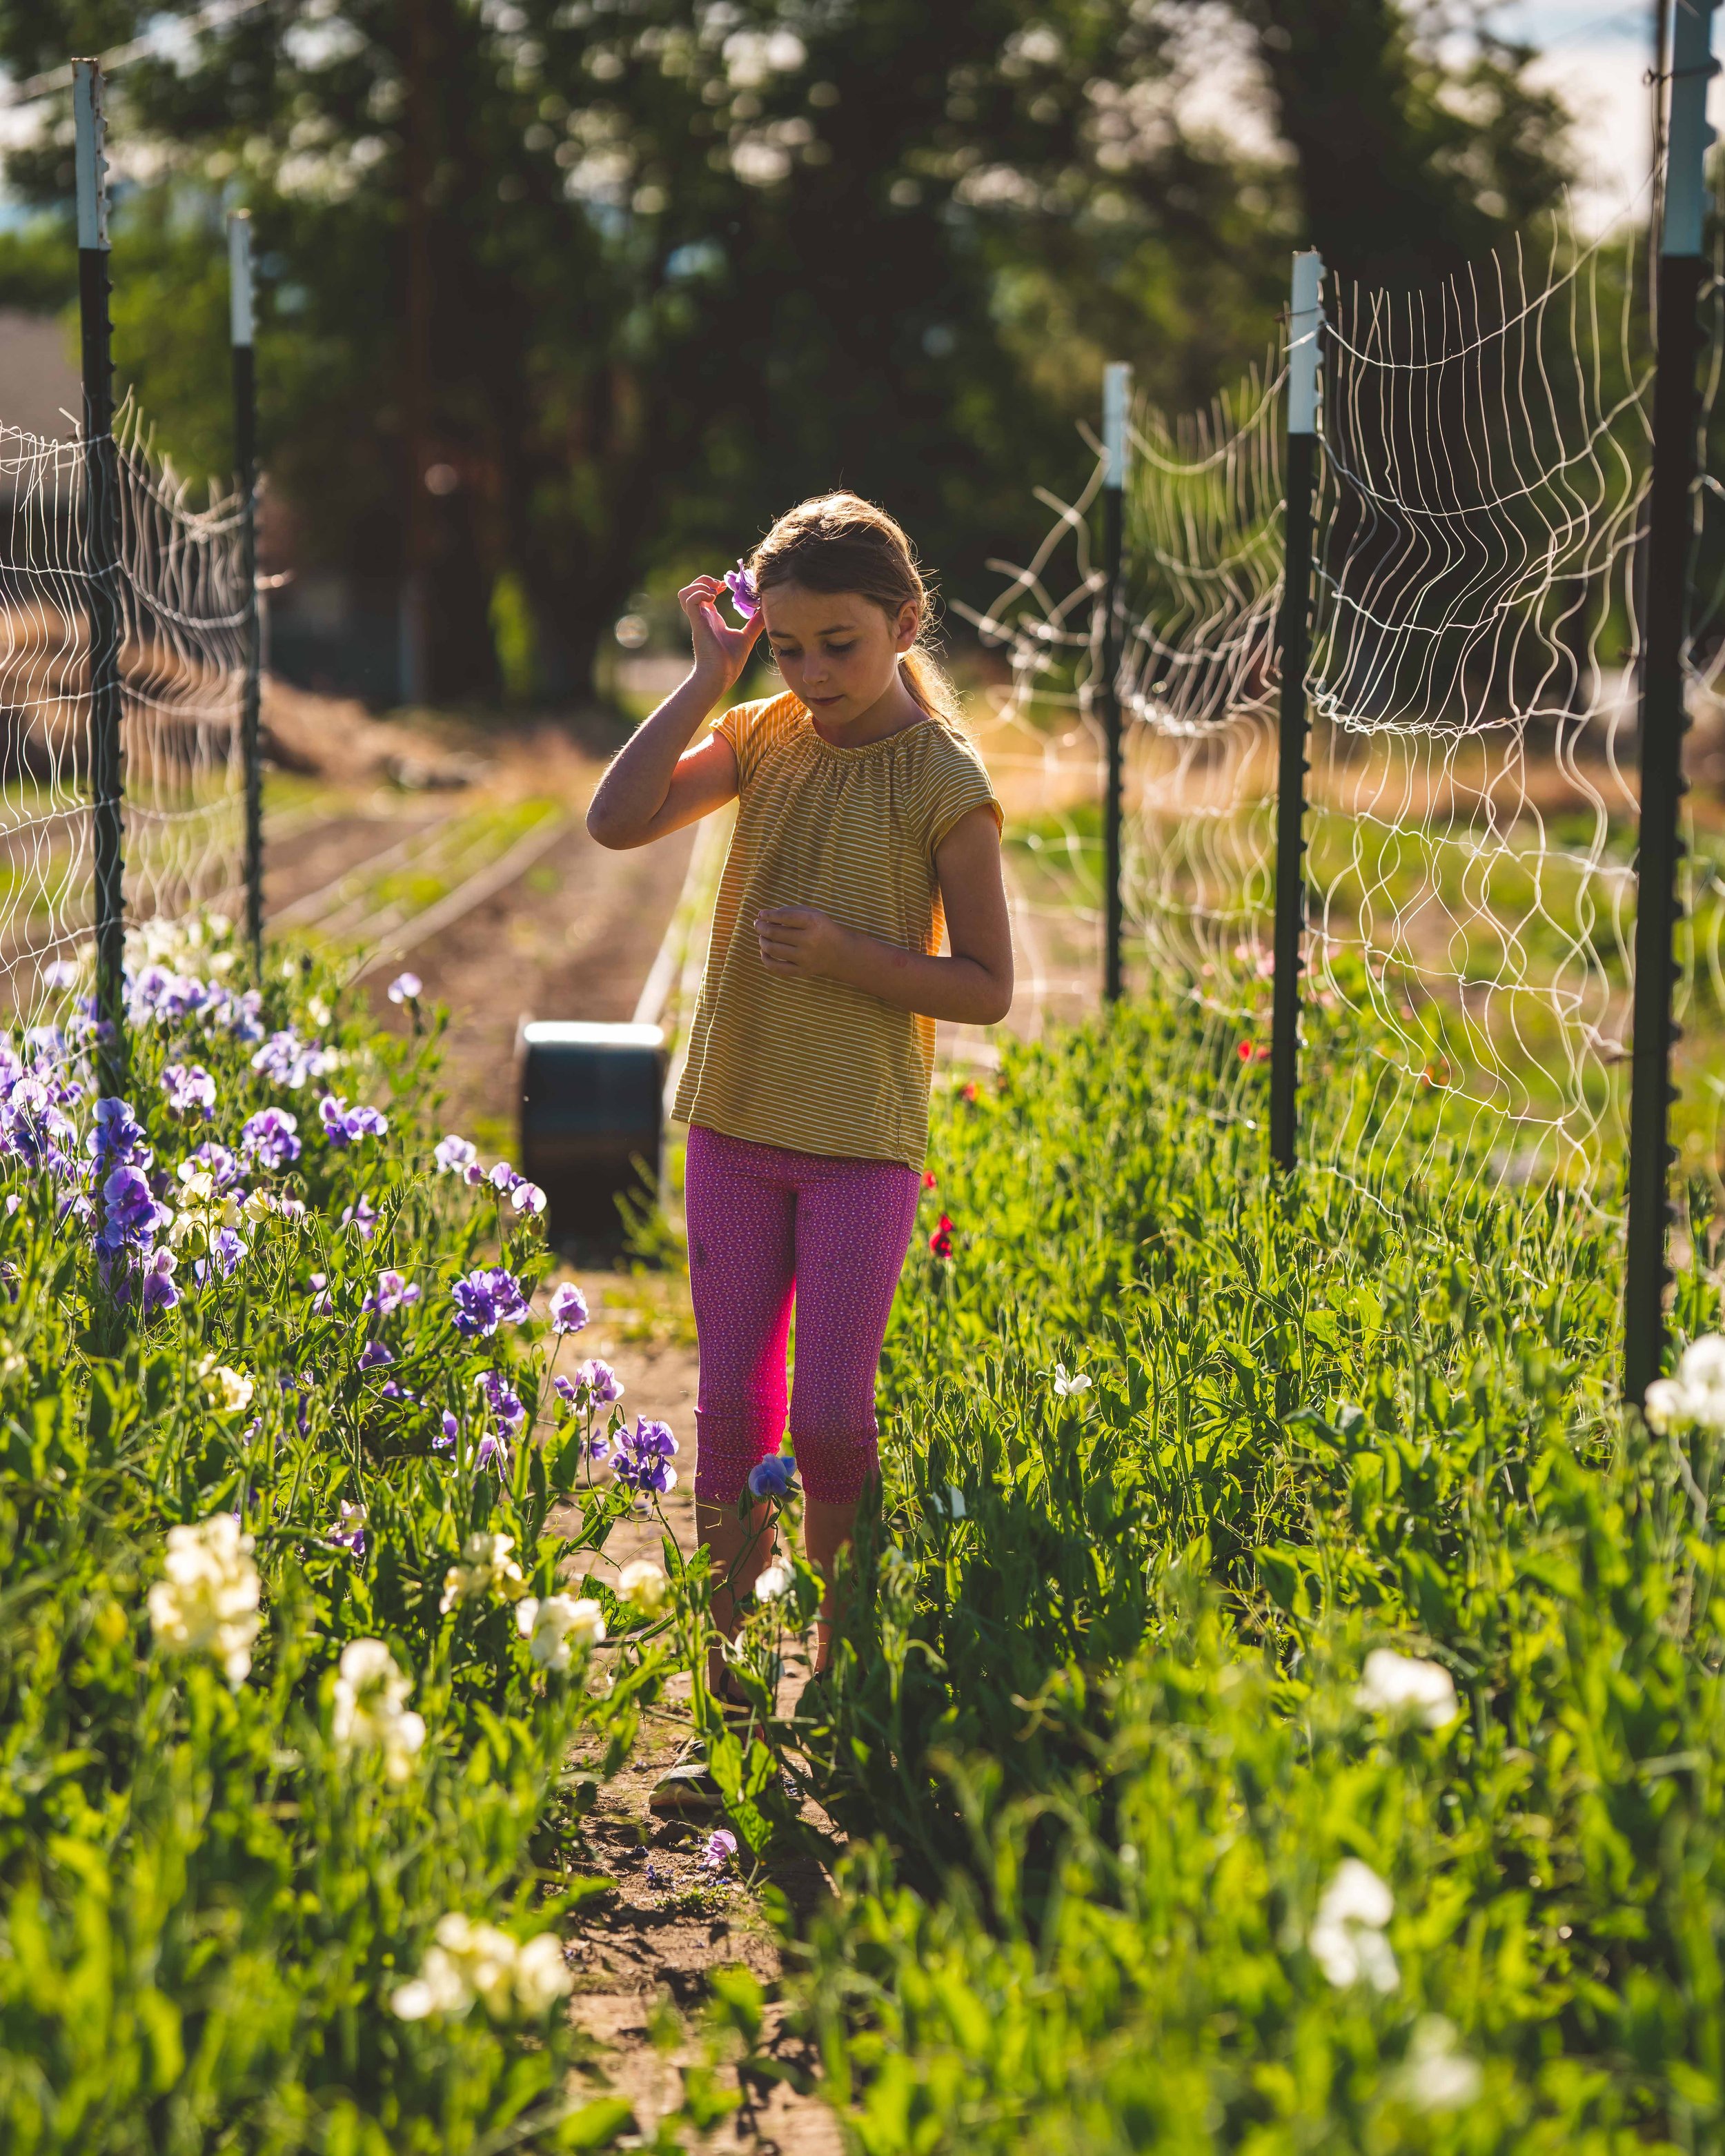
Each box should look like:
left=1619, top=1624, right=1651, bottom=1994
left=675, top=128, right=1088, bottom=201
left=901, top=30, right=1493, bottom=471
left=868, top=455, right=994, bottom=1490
left=970, top=225, right=1725, bottom=1194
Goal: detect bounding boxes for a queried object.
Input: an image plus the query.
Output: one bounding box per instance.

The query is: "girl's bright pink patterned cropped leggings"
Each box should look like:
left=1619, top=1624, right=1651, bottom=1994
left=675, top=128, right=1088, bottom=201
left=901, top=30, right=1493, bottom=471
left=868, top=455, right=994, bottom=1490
left=684, top=1123, right=920, bottom=1505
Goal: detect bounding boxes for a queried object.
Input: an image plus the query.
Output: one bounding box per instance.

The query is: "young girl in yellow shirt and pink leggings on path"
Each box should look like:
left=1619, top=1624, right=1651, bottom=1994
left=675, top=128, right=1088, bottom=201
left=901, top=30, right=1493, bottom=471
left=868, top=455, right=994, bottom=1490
left=586, top=494, right=1012, bottom=1809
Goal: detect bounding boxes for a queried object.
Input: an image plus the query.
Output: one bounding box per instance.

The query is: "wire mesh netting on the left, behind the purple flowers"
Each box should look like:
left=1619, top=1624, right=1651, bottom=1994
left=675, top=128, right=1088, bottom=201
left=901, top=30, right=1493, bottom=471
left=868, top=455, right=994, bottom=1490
left=0, top=408, right=248, bottom=1022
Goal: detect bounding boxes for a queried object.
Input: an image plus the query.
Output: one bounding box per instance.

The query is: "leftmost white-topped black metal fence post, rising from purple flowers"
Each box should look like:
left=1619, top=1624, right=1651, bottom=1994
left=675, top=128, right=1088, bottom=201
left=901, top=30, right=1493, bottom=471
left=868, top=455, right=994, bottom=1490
left=73, top=61, right=127, bottom=1098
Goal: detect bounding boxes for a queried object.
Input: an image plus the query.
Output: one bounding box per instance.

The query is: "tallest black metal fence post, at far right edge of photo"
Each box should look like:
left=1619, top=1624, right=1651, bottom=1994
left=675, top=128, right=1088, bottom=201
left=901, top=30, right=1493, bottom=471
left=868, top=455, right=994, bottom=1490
left=1624, top=0, right=1714, bottom=1406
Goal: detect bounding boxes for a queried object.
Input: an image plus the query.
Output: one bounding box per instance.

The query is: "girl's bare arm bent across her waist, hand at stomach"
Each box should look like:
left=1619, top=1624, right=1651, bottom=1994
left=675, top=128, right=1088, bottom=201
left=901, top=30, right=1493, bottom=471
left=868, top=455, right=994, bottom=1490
left=755, top=809, right=1012, bottom=1027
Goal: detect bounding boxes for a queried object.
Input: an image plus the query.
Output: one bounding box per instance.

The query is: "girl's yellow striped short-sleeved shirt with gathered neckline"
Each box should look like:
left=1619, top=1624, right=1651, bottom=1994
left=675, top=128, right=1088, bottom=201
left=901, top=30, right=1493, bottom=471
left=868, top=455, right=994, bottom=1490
left=673, top=692, right=1000, bottom=1169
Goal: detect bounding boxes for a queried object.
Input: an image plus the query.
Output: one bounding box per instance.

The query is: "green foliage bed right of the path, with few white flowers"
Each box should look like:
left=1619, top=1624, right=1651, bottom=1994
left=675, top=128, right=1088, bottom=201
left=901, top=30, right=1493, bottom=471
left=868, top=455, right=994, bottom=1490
left=776, top=1005, right=1725, bottom=2156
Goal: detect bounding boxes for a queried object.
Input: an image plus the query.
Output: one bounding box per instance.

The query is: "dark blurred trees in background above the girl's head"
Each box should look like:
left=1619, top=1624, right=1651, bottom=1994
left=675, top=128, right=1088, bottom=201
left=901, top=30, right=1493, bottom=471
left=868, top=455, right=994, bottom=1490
left=0, top=0, right=1587, bottom=696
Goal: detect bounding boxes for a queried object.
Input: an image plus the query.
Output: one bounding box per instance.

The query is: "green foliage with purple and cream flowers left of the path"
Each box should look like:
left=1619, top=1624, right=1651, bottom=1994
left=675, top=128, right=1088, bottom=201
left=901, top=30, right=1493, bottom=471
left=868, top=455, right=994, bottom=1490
left=0, top=918, right=673, bottom=2156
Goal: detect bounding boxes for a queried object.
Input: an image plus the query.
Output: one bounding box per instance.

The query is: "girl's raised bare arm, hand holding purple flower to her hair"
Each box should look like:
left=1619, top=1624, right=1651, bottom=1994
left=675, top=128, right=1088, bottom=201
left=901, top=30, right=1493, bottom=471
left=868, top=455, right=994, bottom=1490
left=586, top=575, right=759, bottom=849
